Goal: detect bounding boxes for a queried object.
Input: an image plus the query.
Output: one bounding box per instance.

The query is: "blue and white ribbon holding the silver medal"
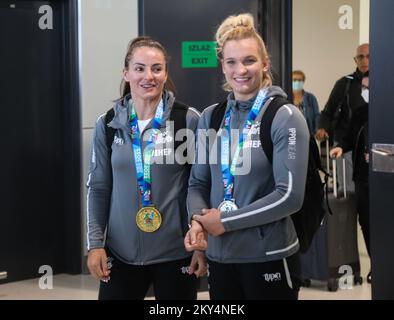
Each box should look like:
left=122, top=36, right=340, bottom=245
left=220, top=90, right=268, bottom=200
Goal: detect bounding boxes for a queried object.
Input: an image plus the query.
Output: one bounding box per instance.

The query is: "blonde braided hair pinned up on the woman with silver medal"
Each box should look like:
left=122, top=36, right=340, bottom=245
left=215, top=13, right=272, bottom=91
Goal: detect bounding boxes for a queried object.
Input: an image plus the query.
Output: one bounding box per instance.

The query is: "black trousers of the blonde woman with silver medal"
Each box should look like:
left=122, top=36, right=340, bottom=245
left=208, top=254, right=300, bottom=300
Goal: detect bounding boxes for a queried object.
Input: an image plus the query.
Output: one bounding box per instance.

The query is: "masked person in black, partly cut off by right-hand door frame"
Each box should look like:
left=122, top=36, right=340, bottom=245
left=330, top=77, right=371, bottom=283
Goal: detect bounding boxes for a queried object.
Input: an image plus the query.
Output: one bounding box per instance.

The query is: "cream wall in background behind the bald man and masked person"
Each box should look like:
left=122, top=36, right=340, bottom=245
left=293, top=0, right=360, bottom=109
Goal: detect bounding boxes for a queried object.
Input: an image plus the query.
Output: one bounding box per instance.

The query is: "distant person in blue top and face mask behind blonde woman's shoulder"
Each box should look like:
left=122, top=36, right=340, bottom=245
left=293, top=70, right=320, bottom=136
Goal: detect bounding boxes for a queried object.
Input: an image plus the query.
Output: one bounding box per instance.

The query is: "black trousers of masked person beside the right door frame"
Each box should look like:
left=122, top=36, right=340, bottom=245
left=354, top=180, right=371, bottom=256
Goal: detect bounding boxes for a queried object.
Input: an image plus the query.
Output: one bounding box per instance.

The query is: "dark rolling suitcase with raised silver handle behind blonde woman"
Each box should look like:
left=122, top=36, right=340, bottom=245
left=300, top=144, right=362, bottom=291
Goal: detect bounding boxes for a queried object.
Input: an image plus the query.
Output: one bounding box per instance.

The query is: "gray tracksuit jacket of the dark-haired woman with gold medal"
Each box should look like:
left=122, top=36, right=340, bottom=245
left=87, top=92, right=199, bottom=265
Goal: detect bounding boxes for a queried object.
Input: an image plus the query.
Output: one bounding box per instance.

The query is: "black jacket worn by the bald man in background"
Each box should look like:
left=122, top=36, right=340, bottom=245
left=318, top=69, right=368, bottom=141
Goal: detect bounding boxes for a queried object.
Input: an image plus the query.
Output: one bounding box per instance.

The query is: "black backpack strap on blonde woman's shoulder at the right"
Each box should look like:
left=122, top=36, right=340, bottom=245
left=260, top=97, right=290, bottom=164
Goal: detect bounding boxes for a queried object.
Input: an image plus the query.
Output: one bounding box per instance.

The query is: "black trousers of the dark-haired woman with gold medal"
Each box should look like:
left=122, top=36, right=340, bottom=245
left=99, top=253, right=199, bottom=300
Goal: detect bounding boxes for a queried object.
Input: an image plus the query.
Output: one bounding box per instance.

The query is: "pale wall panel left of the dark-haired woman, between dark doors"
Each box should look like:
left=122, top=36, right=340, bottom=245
left=79, top=0, right=138, bottom=253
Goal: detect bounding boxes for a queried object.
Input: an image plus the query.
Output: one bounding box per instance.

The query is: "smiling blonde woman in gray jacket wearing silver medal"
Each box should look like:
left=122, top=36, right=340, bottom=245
left=185, top=14, right=309, bottom=300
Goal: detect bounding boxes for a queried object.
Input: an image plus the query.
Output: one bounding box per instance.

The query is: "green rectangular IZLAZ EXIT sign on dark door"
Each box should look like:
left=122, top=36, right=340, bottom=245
left=182, top=41, right=218, bottom=68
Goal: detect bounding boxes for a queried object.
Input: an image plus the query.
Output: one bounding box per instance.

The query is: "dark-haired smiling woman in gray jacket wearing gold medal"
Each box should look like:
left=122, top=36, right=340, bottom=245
left=87, top=37, right=206, bottom=300
